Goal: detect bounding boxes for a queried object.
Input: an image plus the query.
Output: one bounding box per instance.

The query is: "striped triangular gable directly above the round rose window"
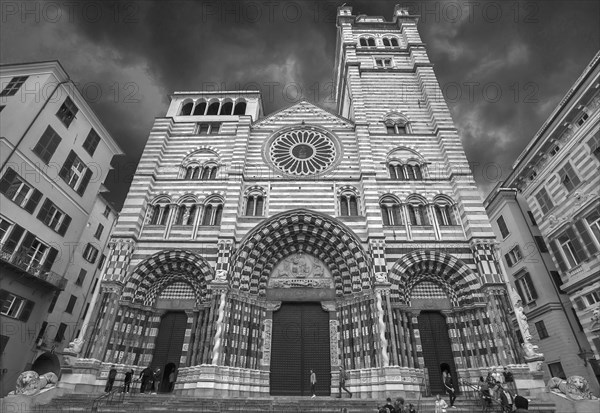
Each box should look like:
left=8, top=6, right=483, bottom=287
left=253, top=100, right=354, bottom=128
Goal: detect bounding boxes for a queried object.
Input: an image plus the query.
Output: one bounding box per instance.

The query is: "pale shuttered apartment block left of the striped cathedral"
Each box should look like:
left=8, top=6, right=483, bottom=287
left=0, top=61, right=122, bottom=396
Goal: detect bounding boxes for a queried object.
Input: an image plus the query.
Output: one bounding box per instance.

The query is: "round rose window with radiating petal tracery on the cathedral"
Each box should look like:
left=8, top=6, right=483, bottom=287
left=269, top=127, right=338, bottom=175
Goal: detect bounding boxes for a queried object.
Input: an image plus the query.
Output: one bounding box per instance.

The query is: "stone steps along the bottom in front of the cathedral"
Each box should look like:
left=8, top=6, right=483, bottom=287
left=32, top=394, right=564, bottom=413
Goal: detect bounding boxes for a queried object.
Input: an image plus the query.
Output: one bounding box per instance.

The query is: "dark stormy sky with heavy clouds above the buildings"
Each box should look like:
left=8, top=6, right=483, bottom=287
left=0, top=0, right=600, bottom=205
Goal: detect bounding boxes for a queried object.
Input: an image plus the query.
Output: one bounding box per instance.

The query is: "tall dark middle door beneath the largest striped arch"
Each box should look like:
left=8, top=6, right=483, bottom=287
left=271, top=302, right=331, bottom=396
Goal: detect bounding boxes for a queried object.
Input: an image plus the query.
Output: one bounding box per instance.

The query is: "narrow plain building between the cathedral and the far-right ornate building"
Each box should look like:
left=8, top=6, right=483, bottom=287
left=484, top=183, right=600, bottom=393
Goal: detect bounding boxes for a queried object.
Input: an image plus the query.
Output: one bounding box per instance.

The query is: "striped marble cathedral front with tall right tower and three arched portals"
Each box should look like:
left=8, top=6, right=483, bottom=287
left=75, top=6, right=526, bottom=397
